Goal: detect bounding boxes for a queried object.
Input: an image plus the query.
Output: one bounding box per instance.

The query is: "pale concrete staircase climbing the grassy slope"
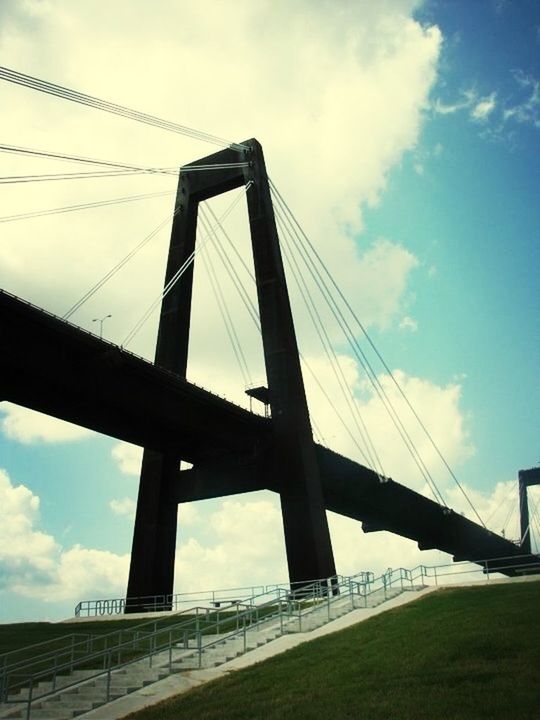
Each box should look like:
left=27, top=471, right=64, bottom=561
left=0, top=586, right=421, bottom=720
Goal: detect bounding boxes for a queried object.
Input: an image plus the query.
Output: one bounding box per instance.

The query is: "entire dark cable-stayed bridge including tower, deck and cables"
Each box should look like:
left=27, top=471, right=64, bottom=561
left=0, top=69, right=538, bottom=609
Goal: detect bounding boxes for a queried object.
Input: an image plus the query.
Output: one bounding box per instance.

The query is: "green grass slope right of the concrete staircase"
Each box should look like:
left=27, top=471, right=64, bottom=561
left=124, top=582, right=540, bottom=720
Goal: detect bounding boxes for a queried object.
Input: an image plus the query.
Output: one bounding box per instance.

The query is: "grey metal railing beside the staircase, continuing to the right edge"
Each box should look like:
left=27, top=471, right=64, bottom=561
left=0, top=556, right=540, bottom=719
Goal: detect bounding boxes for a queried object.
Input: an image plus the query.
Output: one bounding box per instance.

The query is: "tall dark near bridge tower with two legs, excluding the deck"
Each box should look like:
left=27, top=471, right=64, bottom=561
left=127, top=139, right=335, bottom=611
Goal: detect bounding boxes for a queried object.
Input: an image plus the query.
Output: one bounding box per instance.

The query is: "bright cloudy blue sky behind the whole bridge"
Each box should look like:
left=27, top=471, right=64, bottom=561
left=0, top=0, right=540, bottom=622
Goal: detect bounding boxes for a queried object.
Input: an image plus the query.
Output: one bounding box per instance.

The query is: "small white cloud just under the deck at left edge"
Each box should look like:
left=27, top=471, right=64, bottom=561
left=0, top=402, right=93, bottom=444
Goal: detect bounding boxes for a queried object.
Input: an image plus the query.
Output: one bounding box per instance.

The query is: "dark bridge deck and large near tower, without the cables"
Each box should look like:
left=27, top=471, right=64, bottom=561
left=0, top=140, right=538, bottom=609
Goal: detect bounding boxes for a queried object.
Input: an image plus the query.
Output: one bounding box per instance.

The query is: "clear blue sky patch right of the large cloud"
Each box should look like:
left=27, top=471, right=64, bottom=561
left=367, top=2, right=540, bottom=489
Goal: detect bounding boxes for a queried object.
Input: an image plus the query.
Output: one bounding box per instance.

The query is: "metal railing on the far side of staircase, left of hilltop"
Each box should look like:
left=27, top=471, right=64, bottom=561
left=0, top=577, right=376, bottom=717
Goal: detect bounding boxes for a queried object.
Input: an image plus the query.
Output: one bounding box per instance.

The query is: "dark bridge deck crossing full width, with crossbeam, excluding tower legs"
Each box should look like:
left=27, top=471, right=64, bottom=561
left=0, top=291, right=539, bottom=574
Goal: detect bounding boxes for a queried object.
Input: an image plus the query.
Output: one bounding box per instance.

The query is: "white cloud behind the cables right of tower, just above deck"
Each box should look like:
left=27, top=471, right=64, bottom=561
left=305, top=356, right=474, bottom=494
